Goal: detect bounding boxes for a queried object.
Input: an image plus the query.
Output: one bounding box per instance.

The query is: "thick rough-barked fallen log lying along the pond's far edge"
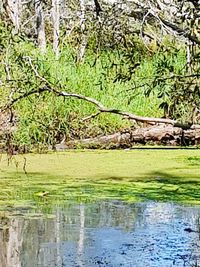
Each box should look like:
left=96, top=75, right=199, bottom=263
left=55, top=124, right=200, bottom=151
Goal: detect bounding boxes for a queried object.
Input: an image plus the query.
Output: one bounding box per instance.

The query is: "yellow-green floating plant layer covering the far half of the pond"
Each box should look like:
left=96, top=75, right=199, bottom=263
left=0, top=149, right=200, bottom=213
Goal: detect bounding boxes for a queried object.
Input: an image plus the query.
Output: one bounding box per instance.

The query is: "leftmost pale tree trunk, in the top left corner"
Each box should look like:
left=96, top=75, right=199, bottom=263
left=6, top=0, right=22, bottom=33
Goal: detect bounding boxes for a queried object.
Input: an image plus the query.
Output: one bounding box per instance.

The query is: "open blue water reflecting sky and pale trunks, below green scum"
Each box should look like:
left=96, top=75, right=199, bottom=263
left=0, top=201, right=200, bottom=267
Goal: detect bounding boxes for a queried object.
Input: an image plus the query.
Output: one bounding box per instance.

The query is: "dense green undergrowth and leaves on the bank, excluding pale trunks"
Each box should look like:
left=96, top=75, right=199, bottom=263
left=0, top=1, right=200, bottom=151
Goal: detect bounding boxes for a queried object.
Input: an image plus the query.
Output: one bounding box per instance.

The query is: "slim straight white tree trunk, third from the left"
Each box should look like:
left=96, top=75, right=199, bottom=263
left=52, top=0, right=60, bottom=58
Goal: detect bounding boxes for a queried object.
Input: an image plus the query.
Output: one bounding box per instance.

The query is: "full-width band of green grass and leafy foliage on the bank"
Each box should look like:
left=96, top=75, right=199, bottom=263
left=0, top=19, right=200, bottom=149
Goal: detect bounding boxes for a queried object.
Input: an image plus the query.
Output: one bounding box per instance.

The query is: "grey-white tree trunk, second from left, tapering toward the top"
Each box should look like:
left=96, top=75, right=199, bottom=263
left=35, top=0, right=46, bottom=53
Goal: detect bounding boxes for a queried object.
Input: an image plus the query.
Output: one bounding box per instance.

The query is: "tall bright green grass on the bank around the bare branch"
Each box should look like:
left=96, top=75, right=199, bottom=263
left=0, top=30, right=188, bottom=151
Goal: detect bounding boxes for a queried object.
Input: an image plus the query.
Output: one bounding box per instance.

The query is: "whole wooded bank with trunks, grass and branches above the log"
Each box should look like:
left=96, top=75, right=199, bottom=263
left=0, top=0, right=200, bottom=150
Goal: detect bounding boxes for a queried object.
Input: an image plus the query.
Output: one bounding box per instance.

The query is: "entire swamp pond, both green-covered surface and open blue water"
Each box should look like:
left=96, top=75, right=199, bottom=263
left=0, top=150, right=200, bottom=267
